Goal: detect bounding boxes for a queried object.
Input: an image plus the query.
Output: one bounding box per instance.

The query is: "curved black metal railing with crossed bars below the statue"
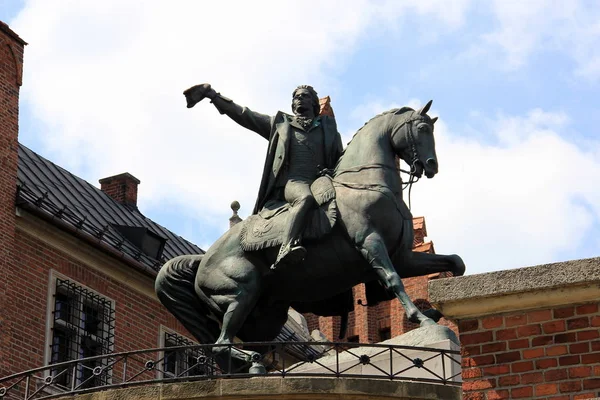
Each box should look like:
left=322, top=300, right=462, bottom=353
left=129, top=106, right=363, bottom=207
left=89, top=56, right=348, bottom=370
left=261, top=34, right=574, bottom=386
left=0, top=342, right=461, bottom=400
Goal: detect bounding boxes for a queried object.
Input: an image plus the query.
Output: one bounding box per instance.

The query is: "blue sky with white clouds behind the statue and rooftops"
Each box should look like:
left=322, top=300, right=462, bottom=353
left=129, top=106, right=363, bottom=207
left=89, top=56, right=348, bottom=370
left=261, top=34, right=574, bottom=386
left=0, top=0, right=600, bottom=274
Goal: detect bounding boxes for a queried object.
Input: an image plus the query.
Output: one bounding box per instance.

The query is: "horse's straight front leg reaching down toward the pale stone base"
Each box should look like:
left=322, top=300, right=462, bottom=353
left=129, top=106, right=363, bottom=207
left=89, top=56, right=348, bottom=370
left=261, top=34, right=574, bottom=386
left=358, top=232, right=435, bottom=326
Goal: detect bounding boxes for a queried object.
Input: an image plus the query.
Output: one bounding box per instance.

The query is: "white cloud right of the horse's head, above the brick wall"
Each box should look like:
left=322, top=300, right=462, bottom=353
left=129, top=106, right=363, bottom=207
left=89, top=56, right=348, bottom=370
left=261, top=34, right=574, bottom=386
left=412, top=110, right=600, bottom=274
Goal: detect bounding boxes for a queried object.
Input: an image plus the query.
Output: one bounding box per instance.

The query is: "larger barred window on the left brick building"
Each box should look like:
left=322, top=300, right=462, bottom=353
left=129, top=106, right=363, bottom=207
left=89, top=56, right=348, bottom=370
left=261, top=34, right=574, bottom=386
left=50, top=278, right=115, bottom=388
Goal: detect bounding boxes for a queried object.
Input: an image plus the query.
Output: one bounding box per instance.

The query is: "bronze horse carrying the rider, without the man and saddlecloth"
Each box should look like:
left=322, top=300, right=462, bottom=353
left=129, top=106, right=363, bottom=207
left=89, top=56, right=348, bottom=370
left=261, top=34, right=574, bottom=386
left=156, top=101, right=465, bottom=372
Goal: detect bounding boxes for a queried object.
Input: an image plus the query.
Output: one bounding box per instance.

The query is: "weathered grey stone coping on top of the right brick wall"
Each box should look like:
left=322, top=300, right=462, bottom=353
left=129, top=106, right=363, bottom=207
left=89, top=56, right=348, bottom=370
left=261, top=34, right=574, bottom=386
left=429, top=257, right=600, bottom=319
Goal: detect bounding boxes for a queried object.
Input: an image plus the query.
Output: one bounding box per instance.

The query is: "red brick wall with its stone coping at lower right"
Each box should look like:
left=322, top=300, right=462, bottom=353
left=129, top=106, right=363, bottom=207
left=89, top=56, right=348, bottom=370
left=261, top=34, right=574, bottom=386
left=429, top=258, right=600, bottom=400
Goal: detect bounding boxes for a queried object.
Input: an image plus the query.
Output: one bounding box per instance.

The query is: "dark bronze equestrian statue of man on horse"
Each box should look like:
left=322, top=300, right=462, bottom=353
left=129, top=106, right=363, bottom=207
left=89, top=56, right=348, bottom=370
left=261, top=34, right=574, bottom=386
left=156, top=84, right=465, bottom=372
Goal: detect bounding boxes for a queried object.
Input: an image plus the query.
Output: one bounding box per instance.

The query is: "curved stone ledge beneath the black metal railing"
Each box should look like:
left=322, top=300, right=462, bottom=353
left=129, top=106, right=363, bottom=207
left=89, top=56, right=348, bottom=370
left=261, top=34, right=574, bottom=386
left=55, top=377, right=462, bottom=400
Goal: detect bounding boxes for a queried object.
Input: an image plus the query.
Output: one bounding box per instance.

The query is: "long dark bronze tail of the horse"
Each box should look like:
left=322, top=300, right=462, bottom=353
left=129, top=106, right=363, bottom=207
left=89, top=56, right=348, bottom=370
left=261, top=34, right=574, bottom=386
left=154, top=254, right=221, bottom=344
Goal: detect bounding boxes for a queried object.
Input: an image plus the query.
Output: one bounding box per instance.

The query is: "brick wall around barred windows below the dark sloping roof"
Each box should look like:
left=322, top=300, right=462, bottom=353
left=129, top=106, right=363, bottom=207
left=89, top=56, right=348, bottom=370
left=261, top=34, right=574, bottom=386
left=0, top=220, right=192, bottom=376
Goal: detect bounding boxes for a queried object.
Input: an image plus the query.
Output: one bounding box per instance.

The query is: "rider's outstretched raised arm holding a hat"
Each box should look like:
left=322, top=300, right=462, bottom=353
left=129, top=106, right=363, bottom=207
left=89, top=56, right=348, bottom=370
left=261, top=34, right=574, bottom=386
left=183, top=83, right=273, bottom=140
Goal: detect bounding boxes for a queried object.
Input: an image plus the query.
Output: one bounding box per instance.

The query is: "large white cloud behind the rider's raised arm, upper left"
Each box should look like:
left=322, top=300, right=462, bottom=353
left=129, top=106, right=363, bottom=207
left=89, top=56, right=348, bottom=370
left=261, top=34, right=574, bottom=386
left=11, top=0, right=468, bottom=230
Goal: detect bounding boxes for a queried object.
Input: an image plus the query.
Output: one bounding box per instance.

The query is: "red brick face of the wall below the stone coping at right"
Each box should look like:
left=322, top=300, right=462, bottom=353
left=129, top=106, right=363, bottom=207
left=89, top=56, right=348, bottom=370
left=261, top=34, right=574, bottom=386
left=459, top=302, right=600, bottom=400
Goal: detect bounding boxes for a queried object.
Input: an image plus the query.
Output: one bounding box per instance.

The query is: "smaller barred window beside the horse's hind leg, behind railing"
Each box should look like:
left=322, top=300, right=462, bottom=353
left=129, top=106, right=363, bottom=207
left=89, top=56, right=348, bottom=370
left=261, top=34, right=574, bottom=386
left=161, top=331, right=214, bottom=378
